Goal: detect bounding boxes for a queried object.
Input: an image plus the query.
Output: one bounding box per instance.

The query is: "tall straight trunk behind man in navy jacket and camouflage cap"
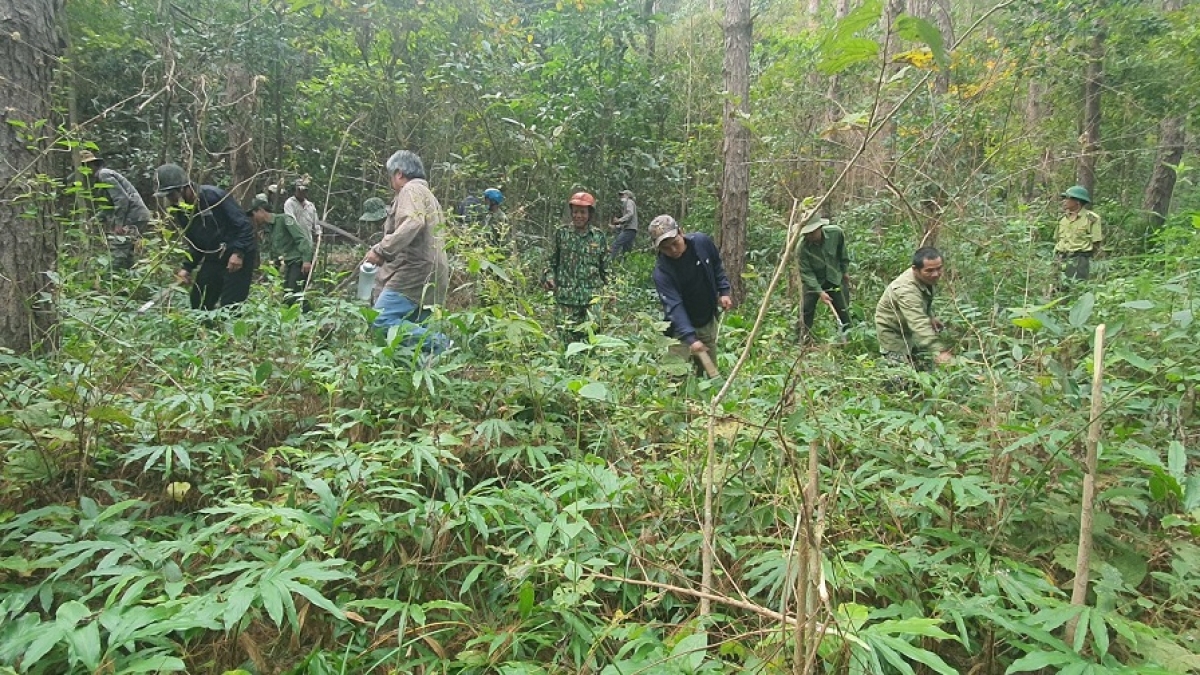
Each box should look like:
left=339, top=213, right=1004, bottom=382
left=720, top=0, right=752, bottom=301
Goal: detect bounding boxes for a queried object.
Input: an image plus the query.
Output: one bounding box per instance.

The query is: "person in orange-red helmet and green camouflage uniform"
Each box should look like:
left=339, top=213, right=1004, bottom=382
left=542, top=192, right=608, bottom=342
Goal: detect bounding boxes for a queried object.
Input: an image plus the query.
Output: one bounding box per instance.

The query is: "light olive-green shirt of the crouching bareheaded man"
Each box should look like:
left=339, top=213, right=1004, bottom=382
left=875, top=268, right=942, bottom=357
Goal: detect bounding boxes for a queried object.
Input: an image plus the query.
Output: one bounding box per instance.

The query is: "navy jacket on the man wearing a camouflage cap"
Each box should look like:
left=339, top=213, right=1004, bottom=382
left=653, top=232, right=732, bottom=346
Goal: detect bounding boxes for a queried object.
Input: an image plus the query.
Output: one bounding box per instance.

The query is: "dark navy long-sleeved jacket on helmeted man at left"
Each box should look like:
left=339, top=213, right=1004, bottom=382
left=175, top=185, right=258, bottom=270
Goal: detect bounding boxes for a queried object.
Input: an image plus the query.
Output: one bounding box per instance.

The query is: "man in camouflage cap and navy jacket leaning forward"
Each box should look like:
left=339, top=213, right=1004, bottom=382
left=650, top=215, right=733, bottom=372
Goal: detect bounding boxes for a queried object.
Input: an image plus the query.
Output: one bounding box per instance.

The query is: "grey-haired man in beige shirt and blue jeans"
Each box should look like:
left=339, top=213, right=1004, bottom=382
left=365, top=150, right=450, bottom=353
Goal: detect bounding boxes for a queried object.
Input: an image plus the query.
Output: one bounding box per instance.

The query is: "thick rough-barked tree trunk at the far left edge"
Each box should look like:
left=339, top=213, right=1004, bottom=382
left=0, top=0, right=64, bottom=353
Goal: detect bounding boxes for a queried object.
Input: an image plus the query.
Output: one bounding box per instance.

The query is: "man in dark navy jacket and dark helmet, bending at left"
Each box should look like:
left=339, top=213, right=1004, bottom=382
left=154, top=165, right=258, bottom=310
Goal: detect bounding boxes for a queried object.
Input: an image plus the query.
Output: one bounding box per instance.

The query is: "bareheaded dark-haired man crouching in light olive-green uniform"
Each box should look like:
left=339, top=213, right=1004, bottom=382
left=875, top=246, right=954, bottom=370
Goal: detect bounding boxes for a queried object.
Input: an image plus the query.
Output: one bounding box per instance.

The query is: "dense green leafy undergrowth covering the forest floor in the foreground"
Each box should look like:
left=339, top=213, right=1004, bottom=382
left=0, top=213, right=1200, bottom=675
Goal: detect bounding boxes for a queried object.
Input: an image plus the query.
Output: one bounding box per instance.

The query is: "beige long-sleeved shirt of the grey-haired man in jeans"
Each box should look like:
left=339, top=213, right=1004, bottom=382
left=371, top=178, right=450, bottom=306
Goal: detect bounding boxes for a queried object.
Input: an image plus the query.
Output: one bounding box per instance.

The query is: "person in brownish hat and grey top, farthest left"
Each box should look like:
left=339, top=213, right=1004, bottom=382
left=79, top=150, right=150, bottom=269
